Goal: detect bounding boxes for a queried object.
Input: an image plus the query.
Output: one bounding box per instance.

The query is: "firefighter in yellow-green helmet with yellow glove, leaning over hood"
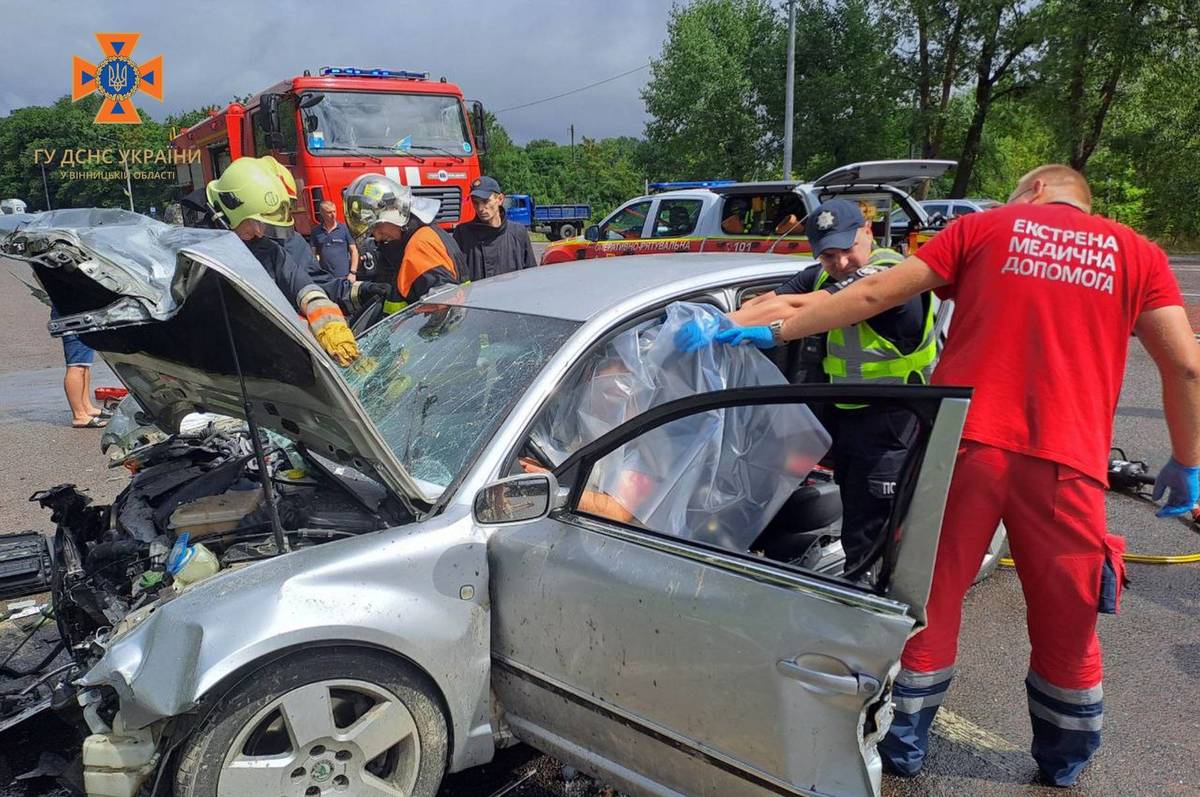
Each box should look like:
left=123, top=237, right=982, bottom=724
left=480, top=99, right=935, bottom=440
left=206, top=157, right=359, bottom=367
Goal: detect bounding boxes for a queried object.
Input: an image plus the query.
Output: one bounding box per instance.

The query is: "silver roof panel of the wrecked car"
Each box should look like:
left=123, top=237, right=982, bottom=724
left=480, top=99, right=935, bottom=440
left=439, top=252, right=811, bottom=322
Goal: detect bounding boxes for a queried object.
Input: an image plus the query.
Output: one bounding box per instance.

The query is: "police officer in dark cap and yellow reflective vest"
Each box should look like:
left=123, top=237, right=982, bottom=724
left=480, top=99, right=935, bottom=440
left=677, top=199, right=937, bottom=571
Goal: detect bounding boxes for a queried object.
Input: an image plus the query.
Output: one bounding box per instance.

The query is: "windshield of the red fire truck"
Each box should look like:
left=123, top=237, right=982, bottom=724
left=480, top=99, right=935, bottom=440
left=301, top=91, right=472, bottom=157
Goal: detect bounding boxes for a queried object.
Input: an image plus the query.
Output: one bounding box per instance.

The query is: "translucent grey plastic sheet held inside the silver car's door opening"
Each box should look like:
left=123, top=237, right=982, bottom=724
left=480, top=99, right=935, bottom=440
left=532, top=302, right=830, bottom=551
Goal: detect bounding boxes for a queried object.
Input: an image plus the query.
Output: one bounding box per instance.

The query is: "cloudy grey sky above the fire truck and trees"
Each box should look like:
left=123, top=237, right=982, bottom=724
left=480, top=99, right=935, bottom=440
left=0, top=0, right=671, bottom=143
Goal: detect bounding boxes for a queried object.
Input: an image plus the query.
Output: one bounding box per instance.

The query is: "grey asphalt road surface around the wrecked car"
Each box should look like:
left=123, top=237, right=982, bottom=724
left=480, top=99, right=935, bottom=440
left=0, top=245, right=1200, bottom=797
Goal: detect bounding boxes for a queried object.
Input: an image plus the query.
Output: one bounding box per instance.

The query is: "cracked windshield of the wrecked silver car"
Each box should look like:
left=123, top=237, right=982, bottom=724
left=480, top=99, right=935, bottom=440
left=344, top=304, right=578, bottom=498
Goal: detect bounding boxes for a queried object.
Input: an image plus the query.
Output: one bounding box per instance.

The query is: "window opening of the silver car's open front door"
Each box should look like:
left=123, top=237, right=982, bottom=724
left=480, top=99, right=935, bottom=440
left=571, top=402, right=926, bottom=579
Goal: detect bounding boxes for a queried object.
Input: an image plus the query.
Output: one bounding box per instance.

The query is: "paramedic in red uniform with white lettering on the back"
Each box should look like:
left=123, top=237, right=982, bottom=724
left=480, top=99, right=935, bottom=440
left=718, top=166, right=1200, bottom=786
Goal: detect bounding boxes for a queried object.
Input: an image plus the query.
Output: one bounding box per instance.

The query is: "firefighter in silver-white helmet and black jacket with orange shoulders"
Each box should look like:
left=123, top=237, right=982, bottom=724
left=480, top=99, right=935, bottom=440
left=342, top=174, right=467, bottom=313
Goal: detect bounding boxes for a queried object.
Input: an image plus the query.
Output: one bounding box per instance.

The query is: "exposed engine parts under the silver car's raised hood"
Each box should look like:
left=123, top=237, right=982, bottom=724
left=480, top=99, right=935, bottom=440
left=0, top=426, right=403, bottom=744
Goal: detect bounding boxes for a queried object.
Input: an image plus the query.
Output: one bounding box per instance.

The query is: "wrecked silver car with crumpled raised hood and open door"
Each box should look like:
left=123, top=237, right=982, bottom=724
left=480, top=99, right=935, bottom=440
left=5, top=211, right=968, bottom=797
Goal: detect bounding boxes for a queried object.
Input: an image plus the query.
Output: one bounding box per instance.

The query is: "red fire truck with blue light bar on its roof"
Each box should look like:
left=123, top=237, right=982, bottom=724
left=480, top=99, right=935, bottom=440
left=172, top=67, right=486, bottom=235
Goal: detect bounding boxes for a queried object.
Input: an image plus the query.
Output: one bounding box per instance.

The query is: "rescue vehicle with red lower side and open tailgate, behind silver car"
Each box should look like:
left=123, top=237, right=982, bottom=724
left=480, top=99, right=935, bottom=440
left=541, top=161, right=954, bottom=265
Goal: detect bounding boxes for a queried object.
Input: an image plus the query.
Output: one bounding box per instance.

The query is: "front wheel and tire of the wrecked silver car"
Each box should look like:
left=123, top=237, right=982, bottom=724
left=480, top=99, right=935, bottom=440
left=174, top=647, right=449, bottom=797
